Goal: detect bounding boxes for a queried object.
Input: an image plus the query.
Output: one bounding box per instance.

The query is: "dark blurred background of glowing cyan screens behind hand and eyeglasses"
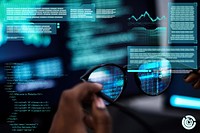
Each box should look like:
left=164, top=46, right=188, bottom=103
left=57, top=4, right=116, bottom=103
left=0, top=0, right=200, bottom=133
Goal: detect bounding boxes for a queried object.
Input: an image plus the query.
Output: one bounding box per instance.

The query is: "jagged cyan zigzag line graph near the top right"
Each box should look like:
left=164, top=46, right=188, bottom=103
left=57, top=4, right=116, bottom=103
left=128, top=11, right=166, bottom=22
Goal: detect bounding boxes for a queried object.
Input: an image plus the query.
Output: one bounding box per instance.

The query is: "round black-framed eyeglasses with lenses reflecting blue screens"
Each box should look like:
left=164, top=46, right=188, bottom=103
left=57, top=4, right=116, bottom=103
left=81, top=58, right=171, bottom=102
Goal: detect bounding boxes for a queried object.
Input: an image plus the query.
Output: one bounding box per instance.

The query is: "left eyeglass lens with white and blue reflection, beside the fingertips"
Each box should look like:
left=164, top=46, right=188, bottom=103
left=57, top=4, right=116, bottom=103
left=88, top=66, right=124, bottom=101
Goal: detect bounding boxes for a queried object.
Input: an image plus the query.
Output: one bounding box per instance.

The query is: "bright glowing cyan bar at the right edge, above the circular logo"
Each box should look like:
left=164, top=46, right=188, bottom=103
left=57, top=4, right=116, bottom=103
left=170, top=95, right=200, bottom=110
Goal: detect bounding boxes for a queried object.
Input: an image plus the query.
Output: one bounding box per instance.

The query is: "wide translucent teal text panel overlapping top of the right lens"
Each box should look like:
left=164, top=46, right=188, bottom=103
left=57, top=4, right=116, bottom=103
left=128, top=46, right=198, bottom=72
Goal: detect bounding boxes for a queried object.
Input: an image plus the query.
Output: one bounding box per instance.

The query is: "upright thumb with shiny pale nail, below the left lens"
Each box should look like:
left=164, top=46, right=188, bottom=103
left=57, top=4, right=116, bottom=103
left=92, top=96, right=112, bottom=133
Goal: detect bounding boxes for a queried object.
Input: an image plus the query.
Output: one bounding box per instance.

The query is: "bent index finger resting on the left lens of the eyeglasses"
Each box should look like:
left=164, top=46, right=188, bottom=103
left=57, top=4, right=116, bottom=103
left=72, top=82, right=102, bottom=102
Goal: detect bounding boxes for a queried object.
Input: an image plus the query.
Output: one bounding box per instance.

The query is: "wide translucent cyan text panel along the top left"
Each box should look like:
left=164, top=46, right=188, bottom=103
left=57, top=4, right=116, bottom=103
left=5, top=4, right=95, bottom=22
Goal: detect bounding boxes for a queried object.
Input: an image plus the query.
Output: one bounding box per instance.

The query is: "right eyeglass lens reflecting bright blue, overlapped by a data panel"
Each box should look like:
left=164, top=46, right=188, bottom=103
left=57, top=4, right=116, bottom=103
left=138, top=58, right=171, bottom=95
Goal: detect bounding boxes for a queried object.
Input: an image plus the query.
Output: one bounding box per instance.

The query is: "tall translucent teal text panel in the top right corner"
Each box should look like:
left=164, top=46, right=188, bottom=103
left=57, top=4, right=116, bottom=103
left=168, top=3, right=197, bottom=44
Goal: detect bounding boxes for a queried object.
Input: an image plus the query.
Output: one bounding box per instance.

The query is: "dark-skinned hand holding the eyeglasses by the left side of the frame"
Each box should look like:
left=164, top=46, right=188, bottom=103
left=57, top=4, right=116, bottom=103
left=49, top=83, right=112, bottom=133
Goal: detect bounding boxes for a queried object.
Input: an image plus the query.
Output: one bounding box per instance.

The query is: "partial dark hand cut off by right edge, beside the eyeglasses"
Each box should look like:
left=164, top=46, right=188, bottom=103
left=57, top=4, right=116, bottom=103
left=185, top=70, right=200, bottom=89
